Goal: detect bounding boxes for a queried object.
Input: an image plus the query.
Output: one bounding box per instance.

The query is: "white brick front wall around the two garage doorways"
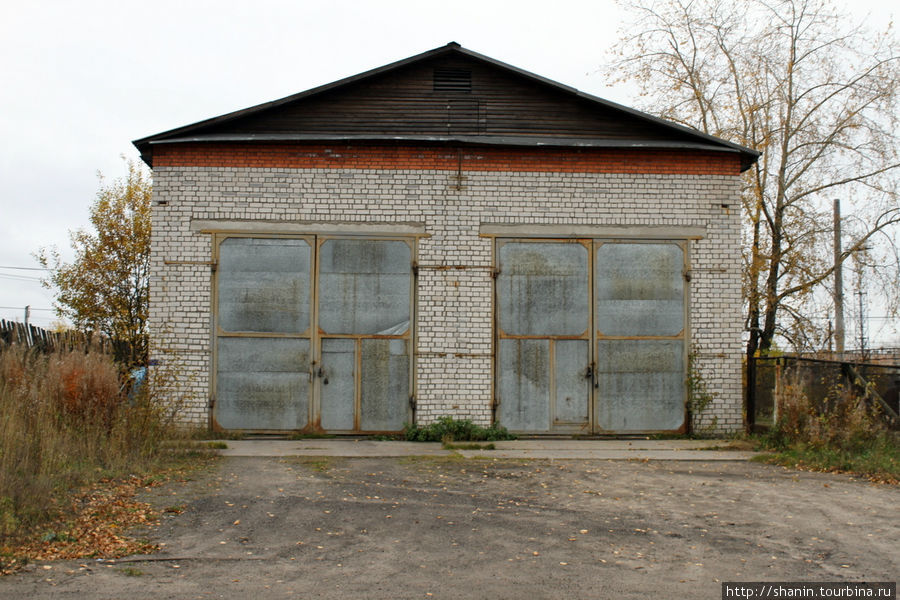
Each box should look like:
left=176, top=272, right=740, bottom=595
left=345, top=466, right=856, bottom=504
left=151, top=167, right=742, bottom=431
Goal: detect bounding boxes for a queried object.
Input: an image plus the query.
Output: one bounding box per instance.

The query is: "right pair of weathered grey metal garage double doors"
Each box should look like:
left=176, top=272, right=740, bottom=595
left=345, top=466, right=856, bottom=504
left=495, top=240, right=685, bottom=433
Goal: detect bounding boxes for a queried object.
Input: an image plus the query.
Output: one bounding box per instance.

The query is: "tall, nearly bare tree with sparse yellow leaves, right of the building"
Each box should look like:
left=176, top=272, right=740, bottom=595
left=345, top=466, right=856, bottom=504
left=607, top=0, right=900, bottom=356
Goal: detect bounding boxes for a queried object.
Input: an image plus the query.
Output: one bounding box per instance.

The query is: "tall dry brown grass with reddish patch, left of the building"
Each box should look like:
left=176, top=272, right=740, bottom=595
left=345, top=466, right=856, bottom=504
left=0, top=346, right=183, bottom=541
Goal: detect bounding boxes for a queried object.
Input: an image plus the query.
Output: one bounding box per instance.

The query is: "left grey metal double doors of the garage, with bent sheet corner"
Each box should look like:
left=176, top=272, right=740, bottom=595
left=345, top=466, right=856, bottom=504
left=213, top=236, right=414, bottom=433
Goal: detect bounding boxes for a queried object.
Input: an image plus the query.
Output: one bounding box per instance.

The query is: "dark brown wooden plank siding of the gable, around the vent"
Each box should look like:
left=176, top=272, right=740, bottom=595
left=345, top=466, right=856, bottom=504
left=198, top=55, right=689, bottom=141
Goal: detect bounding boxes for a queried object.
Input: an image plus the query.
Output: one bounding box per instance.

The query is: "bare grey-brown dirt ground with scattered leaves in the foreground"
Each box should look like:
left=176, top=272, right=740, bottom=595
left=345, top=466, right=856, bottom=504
left=0, top=457, right=900, bottom=599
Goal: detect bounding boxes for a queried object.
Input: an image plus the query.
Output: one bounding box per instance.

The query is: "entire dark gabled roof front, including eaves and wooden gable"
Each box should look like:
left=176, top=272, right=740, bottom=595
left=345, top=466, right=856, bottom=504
left=134, top=42, right=759, bottom=170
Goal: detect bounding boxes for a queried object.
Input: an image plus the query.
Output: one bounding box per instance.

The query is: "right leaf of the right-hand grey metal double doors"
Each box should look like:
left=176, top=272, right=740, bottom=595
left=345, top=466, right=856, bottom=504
left=594, top=242, right=686, bottom=432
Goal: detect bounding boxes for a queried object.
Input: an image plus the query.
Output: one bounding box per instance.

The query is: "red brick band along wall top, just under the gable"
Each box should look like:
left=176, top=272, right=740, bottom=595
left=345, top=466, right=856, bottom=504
left=153, top=143, right=740, bottom=175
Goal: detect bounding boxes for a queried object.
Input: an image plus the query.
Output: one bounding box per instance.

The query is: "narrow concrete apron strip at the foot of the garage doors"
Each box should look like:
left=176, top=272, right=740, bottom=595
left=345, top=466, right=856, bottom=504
left=218, top=439, right=758, bottom=461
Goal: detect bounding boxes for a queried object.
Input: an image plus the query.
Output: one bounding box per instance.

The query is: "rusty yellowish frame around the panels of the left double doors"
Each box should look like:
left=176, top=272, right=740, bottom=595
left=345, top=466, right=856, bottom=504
left=209, top=232, right=421, bottom=433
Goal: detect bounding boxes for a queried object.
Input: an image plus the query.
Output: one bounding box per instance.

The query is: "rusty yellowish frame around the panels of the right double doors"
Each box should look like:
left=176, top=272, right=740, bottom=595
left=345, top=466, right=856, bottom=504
left=491, top=236, right=691, bottom=434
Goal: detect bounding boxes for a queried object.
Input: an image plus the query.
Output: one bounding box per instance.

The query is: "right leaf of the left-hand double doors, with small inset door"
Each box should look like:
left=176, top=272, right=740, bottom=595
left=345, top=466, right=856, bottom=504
left=316, top=239, right=412, bottom=432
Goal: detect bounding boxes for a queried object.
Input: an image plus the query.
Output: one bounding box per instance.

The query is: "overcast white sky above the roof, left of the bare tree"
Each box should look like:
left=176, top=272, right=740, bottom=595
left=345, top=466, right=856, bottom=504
left=0, top=0, right=898, bottom=340
